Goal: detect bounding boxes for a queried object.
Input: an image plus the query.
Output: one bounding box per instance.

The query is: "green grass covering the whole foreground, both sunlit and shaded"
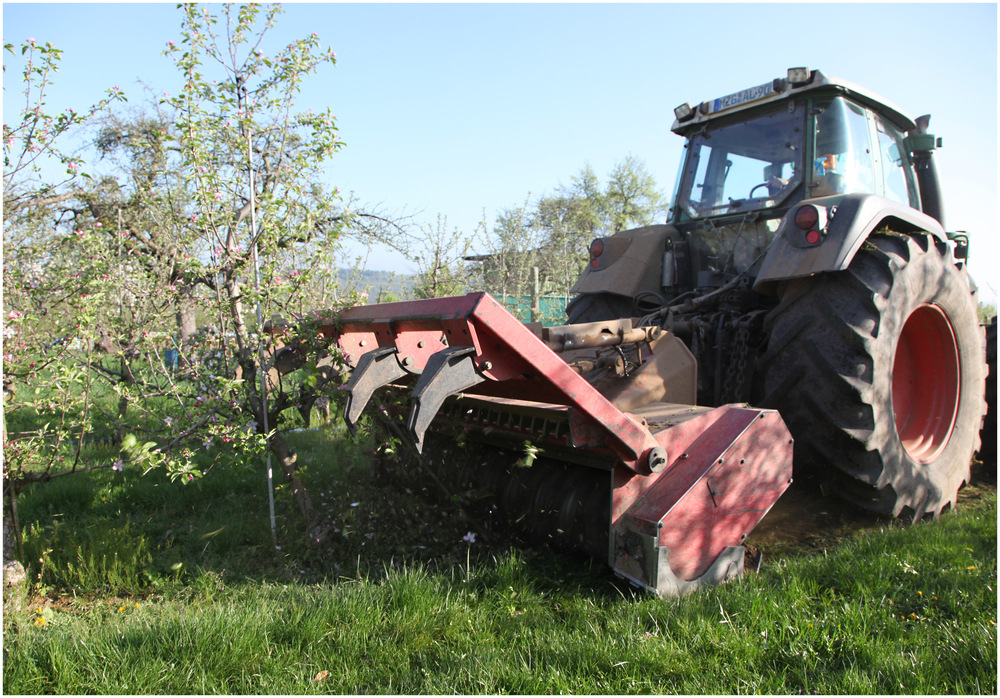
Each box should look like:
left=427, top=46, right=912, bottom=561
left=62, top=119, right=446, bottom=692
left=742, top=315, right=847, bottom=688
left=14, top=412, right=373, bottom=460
left=3, top=430, right=997, bottom=695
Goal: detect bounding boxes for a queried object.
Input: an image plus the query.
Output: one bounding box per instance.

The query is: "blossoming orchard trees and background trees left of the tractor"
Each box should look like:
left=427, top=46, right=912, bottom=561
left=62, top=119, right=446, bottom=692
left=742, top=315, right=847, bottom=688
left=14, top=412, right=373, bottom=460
left=3, top=4, right=665, bottom=539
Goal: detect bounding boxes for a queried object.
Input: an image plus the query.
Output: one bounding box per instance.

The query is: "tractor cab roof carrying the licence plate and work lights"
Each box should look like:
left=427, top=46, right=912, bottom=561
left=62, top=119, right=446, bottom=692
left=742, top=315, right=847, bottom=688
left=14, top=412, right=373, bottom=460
left=670, top=68, right=916, bottom=135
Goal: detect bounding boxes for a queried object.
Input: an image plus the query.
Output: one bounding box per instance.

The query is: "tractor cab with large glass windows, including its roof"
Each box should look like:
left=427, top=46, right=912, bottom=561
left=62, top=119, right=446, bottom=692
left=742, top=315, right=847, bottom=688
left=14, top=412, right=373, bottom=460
left=665, top=69, right=921, bottom=292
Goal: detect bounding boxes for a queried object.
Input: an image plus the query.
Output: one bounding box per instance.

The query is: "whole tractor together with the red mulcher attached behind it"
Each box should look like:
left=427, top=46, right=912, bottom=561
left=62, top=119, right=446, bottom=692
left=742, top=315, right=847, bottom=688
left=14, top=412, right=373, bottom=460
left=308, top=68, right=995, bottom=596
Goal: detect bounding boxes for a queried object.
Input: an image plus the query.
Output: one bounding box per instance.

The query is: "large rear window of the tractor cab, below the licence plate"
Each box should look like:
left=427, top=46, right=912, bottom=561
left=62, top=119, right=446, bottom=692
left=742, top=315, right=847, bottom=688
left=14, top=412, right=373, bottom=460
left=674, top=100, right=804, bottom=218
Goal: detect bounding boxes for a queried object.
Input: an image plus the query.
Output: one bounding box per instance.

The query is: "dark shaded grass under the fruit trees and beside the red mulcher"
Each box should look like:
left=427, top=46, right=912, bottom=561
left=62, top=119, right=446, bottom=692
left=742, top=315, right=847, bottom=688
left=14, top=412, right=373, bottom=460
left=11, top=414, right=995, bottom=608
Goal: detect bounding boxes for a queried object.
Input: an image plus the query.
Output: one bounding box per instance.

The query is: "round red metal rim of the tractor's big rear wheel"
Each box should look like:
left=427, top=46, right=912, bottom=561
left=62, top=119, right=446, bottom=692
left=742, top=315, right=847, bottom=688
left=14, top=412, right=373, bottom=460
left=892, top=304, right=961, bottom=463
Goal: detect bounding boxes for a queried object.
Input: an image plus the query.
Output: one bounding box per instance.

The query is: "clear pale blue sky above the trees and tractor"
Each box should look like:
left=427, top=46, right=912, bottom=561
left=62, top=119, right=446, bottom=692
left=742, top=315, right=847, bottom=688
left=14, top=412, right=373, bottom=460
left=3, top=3, right=1000, bottom=300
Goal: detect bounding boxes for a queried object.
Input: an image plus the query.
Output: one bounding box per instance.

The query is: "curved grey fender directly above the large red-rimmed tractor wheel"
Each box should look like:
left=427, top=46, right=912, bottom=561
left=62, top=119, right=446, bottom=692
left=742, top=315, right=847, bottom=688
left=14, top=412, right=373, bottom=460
left=754, top=194, right=948, bottom=292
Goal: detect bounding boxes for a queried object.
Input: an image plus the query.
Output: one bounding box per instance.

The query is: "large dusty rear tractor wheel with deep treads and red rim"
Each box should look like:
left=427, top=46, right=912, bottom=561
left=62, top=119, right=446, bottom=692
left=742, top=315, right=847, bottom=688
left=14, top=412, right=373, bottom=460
left=758, top=233, right=986, bottom=520
